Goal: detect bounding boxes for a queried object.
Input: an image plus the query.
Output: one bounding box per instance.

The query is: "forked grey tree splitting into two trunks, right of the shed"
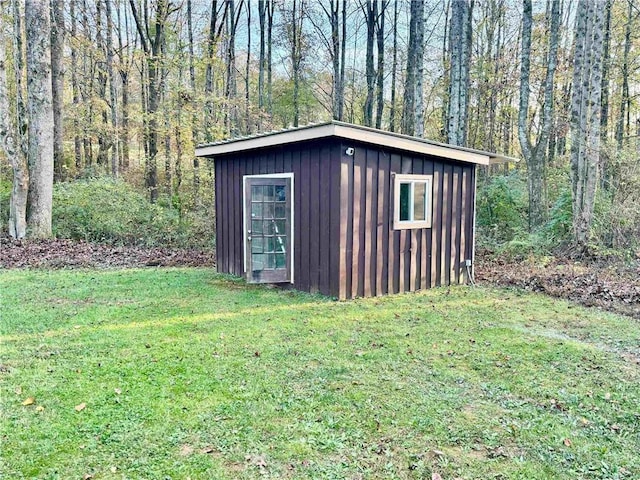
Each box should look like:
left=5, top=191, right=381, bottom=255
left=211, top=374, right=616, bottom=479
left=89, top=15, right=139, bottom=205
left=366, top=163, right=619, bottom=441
left=518, top=0, right=560, bottom=229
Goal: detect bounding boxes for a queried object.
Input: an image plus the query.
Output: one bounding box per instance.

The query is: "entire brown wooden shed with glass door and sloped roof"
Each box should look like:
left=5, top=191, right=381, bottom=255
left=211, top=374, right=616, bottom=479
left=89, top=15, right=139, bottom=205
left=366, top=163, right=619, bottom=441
left=196, top=121, right=514, bottom=299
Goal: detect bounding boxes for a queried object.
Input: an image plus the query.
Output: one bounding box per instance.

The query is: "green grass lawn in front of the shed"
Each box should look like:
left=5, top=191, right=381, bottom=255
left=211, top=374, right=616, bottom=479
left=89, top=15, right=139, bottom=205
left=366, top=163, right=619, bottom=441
left=0, top=269, right=640, bottom=480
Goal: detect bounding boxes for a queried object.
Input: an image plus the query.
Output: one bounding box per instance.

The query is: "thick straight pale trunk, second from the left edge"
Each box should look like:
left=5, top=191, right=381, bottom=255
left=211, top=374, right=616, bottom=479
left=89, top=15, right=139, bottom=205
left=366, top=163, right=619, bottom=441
left=24, top=0, right=53, bottom=238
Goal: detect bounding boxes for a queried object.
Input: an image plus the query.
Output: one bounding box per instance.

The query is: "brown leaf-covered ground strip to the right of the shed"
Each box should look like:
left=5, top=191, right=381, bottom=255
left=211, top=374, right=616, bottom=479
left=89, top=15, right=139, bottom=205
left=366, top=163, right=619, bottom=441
left=476, top=254, right=640, bottom=319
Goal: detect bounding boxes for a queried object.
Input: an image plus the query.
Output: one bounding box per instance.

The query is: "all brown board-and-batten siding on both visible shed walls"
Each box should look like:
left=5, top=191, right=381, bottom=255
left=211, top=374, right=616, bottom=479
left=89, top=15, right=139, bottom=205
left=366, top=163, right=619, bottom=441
left=215, top=138, right=476, bottom=299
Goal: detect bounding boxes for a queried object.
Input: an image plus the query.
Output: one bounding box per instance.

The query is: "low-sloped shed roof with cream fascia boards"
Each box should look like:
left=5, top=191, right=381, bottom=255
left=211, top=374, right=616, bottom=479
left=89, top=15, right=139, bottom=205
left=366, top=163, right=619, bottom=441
left=196, top=120, right=518, bottom=165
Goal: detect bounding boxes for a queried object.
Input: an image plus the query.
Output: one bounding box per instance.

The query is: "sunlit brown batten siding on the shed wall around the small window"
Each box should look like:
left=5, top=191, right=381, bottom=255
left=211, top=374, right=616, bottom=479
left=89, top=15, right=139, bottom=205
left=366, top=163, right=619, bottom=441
left=338, top=142, right=475, bottom=298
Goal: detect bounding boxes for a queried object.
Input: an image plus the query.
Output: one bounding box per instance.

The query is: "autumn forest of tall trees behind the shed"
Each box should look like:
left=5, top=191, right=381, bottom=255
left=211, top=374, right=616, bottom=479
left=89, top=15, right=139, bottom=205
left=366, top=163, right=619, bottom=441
left=0, top=0, right=640, bottom=255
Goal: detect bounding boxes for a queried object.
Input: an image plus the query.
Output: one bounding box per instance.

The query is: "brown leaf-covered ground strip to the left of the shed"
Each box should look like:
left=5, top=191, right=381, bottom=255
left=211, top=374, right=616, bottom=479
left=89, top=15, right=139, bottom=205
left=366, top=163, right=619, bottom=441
left=0, top=238, right=215, bottom=268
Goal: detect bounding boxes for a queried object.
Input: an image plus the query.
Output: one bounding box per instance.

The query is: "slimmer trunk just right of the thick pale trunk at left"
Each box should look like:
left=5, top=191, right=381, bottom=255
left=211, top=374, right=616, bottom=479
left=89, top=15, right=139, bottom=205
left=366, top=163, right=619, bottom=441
left=50, top=0, right=65, bottom=181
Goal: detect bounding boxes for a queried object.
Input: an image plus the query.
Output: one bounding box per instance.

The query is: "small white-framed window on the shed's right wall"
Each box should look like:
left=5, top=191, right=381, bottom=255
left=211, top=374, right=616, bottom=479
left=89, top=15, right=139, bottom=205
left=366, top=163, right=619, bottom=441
left=393, top=174, right=433, bottom=230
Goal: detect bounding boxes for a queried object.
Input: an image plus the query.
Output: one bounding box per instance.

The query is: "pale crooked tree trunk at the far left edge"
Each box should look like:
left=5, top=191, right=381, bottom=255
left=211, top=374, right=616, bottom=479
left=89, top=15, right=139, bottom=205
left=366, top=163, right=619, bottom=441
left=0, top=0, right=29, bottom=239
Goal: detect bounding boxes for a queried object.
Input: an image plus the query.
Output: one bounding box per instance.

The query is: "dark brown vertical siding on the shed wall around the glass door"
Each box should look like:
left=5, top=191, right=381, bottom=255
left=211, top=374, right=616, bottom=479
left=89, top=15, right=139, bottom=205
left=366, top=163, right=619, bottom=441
left=214, top=140, right=340, bottom=297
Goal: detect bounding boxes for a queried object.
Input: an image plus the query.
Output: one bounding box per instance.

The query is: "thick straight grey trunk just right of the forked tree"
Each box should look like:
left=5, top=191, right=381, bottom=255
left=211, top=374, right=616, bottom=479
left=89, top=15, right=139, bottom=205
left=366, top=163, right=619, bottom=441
left=571, top=0, right=604, bottom=250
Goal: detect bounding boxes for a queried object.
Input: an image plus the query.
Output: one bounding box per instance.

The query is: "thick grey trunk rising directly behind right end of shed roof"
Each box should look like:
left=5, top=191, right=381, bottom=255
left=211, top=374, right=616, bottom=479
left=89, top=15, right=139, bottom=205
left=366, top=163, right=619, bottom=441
left=447, top=0, right=474, bottom=145
